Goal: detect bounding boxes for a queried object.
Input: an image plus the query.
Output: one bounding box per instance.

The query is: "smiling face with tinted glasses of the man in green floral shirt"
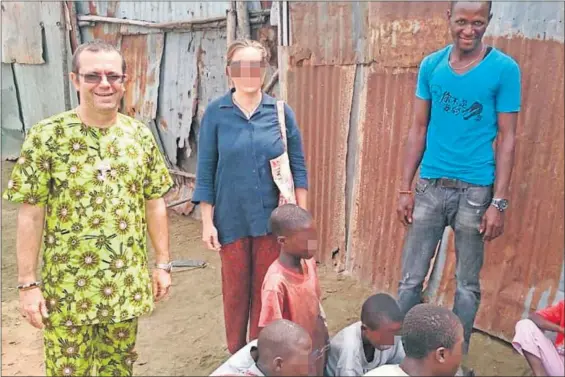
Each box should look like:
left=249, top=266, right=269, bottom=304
left=70, top=51, right=125, bottom=112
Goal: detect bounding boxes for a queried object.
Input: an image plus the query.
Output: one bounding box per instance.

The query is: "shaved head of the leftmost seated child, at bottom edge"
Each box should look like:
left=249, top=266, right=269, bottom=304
left=257, top=319, right=312, bottom=376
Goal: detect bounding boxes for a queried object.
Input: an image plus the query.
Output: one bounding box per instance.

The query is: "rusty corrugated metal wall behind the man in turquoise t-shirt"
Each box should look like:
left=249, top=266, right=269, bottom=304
left=281, top=2, right=565, bottom=340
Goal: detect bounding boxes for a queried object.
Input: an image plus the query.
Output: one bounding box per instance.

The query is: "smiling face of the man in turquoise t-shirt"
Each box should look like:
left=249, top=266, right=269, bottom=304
left=447, top=2, right=490, bottom=52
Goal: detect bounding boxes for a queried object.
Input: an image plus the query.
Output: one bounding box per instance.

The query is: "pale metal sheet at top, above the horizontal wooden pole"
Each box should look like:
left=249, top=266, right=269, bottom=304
left=77, top=1, right=229, bottom=22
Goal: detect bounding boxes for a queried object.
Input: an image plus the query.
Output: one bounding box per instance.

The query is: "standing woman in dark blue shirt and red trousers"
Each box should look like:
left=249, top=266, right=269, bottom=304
left=192, top=40, right=308, bottom=354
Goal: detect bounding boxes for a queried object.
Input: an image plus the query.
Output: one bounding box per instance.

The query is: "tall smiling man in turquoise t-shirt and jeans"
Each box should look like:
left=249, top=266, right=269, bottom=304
left=398, top=2, right=521, bottom=362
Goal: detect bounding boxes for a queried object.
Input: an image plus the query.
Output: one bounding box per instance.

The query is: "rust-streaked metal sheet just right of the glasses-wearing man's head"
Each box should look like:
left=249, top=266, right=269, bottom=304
left=120, top=34, right=165, bottom=122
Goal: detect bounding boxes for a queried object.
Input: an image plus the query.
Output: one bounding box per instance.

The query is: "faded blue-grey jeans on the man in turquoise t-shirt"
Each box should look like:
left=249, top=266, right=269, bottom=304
left=398, top=178, right=493, bottom=353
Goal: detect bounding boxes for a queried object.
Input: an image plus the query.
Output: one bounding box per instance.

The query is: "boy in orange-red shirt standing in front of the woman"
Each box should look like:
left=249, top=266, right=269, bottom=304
left=259, top=204, right=329, bottom=376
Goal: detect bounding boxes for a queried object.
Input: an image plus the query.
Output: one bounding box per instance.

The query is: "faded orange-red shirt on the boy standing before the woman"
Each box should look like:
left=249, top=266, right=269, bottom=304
left=259, top=258, right=329, bottom=376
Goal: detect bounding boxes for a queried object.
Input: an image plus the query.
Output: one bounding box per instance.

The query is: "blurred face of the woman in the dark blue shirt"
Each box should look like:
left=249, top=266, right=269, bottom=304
left=227, top=47, right=266, bottom=93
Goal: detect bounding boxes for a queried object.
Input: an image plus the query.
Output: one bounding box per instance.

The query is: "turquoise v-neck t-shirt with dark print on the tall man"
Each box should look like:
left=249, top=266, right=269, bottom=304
left=416, top=45, right=521, bottom=185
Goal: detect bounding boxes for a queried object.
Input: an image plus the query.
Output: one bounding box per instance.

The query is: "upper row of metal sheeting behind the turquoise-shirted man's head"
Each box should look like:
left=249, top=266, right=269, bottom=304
left=290, top=1, right=564, bottom=68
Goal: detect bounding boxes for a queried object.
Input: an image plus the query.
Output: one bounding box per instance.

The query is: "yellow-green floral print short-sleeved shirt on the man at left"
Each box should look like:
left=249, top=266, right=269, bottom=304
left=4, top=110, right=173, bottom=326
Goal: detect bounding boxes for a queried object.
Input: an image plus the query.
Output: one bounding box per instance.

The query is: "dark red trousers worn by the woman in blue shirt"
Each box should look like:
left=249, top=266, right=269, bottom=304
left=220, top=235, right=280, bottom=354
